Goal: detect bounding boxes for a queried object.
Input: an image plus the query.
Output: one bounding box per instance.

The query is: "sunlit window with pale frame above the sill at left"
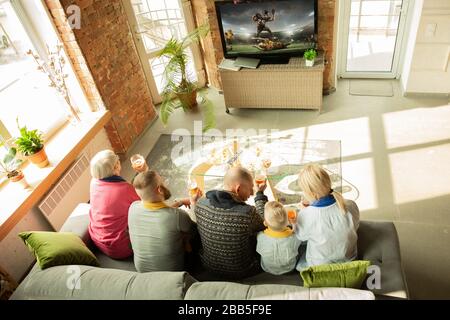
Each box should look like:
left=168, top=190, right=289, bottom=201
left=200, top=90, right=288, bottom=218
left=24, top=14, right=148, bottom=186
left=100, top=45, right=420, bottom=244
left=0, top=0, right=92, bottom=183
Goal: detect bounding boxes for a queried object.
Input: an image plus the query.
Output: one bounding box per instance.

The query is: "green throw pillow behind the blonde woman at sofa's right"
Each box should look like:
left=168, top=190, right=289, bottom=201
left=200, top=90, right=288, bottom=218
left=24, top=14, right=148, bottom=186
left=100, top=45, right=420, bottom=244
left=300, top=260, right=370, bottom=289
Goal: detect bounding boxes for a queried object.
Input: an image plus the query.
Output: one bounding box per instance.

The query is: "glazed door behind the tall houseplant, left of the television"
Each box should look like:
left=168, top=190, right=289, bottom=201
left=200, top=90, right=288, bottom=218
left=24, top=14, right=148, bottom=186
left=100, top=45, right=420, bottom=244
left=122, top=0, right=206, bottom=104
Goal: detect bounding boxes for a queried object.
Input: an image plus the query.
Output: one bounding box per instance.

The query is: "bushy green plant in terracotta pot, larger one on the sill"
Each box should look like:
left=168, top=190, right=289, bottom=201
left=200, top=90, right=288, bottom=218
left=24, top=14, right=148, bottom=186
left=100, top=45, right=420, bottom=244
left=15, top=119, right=48, bottom=168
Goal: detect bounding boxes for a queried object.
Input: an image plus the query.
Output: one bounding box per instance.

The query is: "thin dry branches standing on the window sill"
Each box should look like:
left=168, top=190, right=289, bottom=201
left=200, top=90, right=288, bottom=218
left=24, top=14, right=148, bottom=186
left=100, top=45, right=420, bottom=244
left=27, top=44, right=81, bottom=122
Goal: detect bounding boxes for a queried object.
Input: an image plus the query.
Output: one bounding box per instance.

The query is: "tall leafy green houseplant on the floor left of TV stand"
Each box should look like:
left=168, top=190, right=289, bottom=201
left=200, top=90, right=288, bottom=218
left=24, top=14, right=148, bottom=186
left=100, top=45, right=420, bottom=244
left=157, top=25, right=215, bottom=131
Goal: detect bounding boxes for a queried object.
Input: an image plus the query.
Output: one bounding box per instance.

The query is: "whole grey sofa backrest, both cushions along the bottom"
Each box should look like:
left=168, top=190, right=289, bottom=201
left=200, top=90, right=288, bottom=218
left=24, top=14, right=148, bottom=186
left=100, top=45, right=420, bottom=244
left=11, top=265, right=375, bottom=300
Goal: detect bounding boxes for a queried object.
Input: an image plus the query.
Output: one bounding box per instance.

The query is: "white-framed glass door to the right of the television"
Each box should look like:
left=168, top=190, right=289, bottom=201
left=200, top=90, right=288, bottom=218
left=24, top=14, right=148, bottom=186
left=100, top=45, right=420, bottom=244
left=339, top=0, right=408, bottom=79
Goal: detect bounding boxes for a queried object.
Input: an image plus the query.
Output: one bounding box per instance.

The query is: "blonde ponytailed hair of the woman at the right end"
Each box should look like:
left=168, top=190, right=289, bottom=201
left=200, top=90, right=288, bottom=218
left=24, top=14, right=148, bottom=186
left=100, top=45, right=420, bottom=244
left=298, top=164, right=347, bottom=213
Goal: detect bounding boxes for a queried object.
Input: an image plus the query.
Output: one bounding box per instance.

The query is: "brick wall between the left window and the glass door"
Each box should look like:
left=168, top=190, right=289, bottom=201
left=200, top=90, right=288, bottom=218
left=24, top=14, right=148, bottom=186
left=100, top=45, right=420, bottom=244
left=44, top=0, right=156, bottom=153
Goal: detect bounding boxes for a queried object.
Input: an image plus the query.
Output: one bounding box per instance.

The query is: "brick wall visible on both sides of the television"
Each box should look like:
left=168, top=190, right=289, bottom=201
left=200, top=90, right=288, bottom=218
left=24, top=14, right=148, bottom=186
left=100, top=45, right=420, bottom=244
left=191, top=0, right=336, bottom=93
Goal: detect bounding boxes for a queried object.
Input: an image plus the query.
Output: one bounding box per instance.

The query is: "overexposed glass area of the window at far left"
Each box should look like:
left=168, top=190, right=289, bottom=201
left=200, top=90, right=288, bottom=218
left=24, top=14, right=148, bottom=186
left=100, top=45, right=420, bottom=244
left=0, top=0, right=66, bottom=140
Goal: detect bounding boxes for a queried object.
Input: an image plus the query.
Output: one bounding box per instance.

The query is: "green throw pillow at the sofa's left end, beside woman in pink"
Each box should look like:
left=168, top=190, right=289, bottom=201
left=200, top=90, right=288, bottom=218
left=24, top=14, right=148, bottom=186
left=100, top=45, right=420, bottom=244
left=19, top=231, right=99, bottom=269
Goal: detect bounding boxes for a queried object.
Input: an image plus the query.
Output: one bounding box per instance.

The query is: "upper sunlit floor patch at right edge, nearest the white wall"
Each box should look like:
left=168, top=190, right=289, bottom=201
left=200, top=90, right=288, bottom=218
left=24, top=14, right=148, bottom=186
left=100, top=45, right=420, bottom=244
left=383, top=105, right=450, bottom=149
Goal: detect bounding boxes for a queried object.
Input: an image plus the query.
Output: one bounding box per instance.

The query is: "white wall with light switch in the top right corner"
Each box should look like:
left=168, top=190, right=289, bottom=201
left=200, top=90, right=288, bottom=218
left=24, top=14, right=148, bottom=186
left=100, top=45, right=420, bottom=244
left=401, top=0, right=450, bottom=94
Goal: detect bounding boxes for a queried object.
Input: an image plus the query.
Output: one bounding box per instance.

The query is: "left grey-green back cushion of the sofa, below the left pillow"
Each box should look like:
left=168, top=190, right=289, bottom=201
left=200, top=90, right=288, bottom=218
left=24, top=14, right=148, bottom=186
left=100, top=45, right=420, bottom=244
left=11, top=265, right=195, bottom=300
